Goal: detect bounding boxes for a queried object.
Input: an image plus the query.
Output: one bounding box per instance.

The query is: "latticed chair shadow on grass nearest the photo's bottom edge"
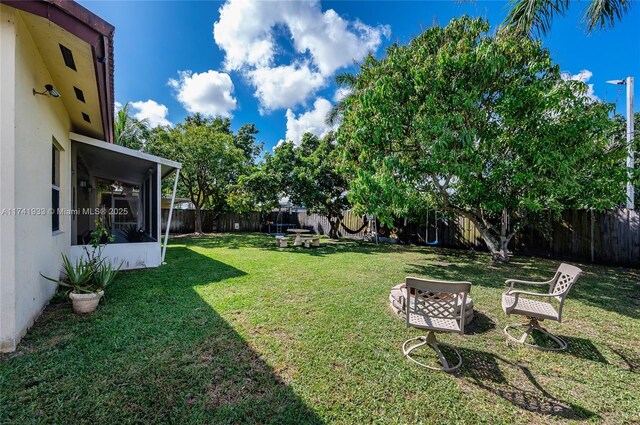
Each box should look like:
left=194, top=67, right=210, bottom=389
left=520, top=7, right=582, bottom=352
left=457, top=348, right=596, bottom=420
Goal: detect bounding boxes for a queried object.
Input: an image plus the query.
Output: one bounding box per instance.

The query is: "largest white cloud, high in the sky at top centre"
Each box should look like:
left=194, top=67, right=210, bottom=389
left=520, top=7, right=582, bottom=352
left=213, top=0, right=390, bottom=110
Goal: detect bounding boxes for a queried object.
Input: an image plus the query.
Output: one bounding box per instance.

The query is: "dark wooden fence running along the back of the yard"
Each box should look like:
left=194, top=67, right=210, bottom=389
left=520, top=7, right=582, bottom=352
left=162, top=209, right=640, bottom=267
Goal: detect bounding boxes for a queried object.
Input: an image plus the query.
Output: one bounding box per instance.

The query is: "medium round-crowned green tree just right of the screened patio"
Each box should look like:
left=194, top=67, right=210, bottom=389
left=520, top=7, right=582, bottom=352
left=146, top=114, right=247, bottom=233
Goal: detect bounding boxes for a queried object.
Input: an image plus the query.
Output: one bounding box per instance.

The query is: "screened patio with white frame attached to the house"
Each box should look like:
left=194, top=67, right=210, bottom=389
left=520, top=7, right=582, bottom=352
left=71, top=133, right=181, bottom=269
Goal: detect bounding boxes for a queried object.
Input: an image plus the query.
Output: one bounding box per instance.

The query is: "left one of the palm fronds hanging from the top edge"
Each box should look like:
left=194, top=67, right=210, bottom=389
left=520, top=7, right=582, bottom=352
left=503, top=0, right=568, bottom=35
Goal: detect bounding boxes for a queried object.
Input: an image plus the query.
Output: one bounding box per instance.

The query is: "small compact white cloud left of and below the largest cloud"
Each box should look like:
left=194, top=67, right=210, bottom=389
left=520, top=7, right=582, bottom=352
left=169, top=70, right=237, bottom=117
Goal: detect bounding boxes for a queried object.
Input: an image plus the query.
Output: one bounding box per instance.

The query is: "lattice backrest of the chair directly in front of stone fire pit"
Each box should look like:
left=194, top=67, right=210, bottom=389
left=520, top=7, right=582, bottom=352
left=405, top=277, right=471, bottom=333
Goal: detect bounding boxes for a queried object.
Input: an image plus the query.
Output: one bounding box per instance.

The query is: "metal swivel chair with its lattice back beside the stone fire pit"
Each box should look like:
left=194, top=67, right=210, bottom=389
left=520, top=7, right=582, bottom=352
left=402, top=277, right=471, bottom=372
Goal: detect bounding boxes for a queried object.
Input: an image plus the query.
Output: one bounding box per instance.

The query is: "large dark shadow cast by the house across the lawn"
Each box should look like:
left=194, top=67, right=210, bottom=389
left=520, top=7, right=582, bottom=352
left=0, top=247, right=322, bottom=424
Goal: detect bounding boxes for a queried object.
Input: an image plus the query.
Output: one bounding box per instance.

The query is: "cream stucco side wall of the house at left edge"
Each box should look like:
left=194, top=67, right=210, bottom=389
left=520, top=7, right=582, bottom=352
left=0, top=5, right=71, bottom=351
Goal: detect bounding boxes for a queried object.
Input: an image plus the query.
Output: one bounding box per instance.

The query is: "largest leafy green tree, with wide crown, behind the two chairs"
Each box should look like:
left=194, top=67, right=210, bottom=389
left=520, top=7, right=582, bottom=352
left=338, top=17, right=626, bottom=261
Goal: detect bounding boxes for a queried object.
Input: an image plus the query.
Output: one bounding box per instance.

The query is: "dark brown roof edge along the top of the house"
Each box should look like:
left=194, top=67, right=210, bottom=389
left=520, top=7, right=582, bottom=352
left=0, top=0, right=115, bottom=143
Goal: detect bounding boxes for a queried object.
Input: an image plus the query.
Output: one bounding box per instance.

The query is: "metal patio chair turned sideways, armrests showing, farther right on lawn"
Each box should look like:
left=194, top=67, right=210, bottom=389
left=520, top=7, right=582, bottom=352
left=502, top=263, right=582, bottom=351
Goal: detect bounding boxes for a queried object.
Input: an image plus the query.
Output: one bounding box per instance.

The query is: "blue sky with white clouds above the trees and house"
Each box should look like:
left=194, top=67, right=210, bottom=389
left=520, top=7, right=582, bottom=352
left=80, top=0, right=640, bottom=150
